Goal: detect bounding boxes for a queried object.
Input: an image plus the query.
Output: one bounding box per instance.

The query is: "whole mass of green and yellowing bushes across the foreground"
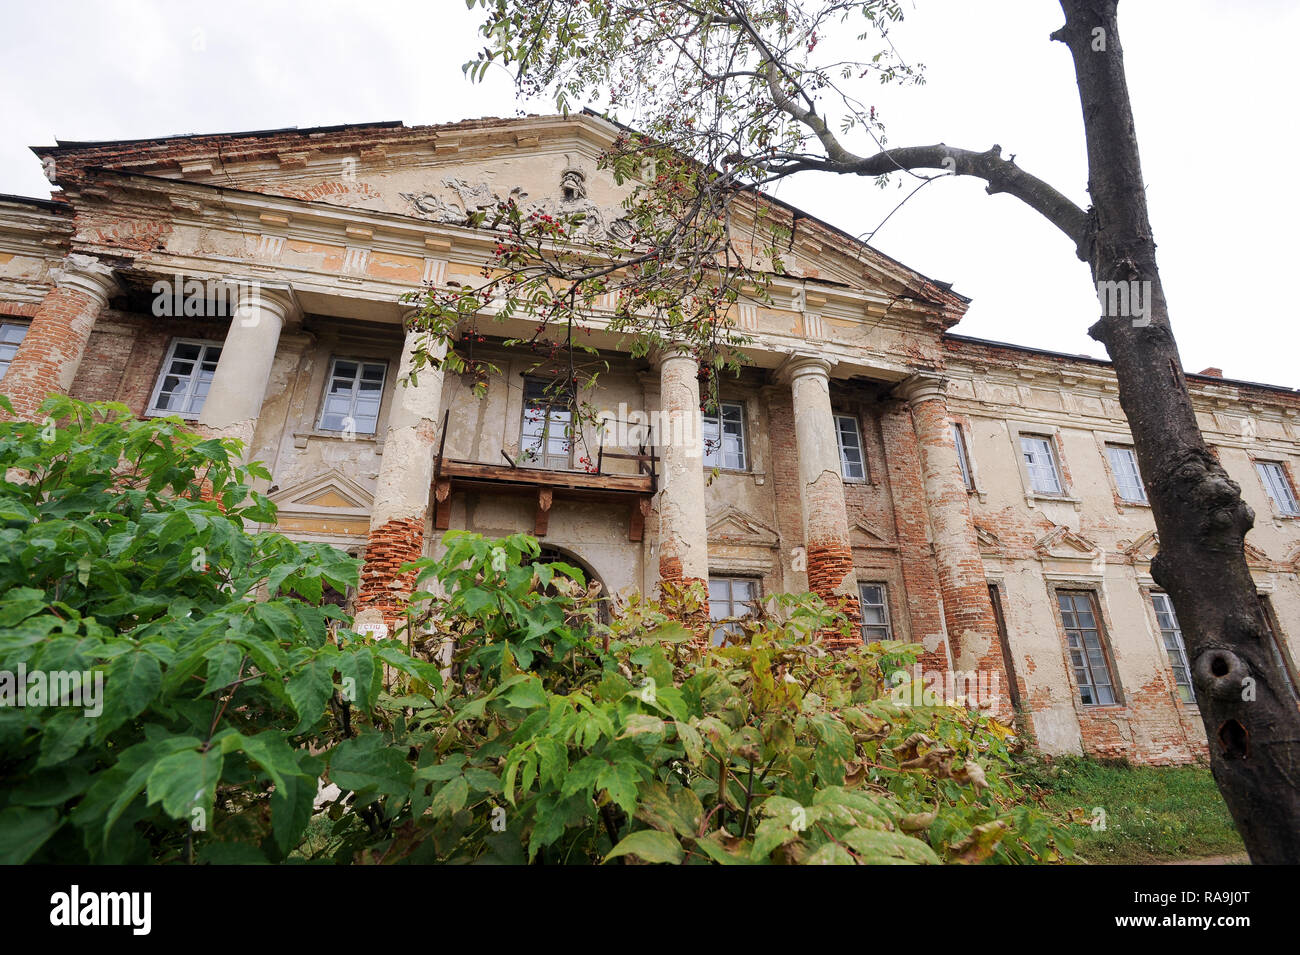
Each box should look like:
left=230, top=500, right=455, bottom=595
left=0, top=399, right=1073, bottom=864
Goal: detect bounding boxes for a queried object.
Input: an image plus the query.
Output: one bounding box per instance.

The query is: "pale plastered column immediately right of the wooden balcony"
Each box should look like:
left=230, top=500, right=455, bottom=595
left=655, top=348, right=709, bottom=586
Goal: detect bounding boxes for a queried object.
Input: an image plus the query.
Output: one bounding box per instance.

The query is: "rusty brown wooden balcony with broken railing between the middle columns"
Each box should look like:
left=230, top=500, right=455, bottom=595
left=433, top=407, right=659, bottom=541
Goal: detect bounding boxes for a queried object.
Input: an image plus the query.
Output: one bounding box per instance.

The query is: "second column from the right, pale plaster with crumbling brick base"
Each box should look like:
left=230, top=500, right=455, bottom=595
left=785, top=356, right=861, bottom=646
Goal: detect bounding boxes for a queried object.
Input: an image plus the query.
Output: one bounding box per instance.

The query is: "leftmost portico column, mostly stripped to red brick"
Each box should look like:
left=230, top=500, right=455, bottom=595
left=0, top=255, right=117, bottom=420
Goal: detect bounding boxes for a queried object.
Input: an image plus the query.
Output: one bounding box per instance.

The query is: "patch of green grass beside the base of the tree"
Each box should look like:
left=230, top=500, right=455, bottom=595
left=1021, top=758, right=1245, bottom=865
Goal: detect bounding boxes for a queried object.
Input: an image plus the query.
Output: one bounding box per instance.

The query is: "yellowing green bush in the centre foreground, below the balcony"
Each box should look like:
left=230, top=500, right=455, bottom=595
left=306, top=531, right=1073, bottom=864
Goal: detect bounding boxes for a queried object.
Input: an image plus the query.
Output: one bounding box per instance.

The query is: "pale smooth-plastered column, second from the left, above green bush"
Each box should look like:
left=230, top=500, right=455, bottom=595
left=199, top=282, right=296, bottom=460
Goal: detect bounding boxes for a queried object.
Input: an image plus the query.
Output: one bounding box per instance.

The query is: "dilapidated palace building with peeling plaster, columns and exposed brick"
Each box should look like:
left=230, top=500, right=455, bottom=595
left=0, top=116, right=1300, bottom=763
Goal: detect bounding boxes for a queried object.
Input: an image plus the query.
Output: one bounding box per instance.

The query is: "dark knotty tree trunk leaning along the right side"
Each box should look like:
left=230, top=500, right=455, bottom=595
left=1053, top=0, right=1300, bottom=863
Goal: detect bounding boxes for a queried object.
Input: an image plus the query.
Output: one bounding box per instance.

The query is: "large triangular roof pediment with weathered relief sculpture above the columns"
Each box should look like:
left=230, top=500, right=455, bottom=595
left=35, top=113, right=965, bottom=310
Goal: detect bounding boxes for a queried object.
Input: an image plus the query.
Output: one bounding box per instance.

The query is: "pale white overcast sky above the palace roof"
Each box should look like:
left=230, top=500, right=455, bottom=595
left=0, top=0, right=1300, bottom=387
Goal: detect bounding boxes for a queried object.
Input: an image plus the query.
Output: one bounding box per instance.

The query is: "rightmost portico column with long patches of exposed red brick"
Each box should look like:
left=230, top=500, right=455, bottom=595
left=897, top=376, right=1010, bottom=711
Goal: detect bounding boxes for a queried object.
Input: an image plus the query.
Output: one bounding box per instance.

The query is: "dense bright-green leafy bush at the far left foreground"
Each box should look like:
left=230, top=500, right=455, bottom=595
left=0, top=399, right=437, bottom=863
